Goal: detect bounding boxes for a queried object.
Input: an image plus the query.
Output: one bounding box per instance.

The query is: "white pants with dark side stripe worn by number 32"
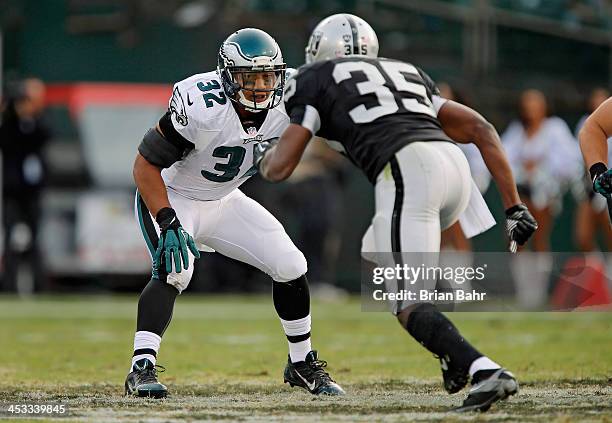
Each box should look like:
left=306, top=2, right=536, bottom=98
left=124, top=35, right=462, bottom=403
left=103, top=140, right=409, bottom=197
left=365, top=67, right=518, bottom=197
left=136, top=189, right=307, bottom=292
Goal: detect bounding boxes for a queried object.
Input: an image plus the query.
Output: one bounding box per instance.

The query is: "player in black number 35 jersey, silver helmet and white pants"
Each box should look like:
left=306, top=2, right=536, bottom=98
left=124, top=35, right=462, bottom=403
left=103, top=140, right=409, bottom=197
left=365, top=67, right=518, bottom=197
left=254, top=14, right=537, bottom=411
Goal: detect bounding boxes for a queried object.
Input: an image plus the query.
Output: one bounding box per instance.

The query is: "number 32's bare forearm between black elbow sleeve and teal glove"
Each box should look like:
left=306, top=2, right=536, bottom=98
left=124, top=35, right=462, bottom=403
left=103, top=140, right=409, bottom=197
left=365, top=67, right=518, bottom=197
left=133, top=153, right=171, bottom=217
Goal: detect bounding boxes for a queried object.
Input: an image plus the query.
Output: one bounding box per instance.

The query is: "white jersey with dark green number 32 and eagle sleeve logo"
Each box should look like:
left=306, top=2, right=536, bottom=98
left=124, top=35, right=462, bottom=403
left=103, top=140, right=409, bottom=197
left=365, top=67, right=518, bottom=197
left=162, top=71, right=289, bottom=201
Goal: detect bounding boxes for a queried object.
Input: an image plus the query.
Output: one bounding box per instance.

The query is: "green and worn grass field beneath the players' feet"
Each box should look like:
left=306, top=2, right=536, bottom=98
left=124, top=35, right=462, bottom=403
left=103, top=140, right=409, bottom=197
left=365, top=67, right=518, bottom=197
left=0, top=294, right=612, bottom=422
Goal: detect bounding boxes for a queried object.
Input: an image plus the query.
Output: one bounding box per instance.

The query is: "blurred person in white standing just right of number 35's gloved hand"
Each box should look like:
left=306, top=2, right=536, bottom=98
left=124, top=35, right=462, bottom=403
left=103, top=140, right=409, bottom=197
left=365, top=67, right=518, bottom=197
left=502, top=89, right=582, bottom=251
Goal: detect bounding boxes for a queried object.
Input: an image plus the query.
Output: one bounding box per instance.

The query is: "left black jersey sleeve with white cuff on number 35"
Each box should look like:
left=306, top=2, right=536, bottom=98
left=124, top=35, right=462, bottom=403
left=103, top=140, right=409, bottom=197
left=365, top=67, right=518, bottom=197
left=284, top=68, right=321, bottom=135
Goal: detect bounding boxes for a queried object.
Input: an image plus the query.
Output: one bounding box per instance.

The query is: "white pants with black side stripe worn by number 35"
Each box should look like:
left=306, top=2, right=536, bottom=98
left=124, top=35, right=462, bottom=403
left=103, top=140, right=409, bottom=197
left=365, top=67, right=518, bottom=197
left=362, top=142, right=472, bottom=313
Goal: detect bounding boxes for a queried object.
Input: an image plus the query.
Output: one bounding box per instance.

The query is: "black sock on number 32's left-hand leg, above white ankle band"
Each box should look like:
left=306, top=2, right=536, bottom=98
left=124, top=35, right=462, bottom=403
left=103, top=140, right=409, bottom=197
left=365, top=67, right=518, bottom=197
left=136, top=279, right=179, bottom=337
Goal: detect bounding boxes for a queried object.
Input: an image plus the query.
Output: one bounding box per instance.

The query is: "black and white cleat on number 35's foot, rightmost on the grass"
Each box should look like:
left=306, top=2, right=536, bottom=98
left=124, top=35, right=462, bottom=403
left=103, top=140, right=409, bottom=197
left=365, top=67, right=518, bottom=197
left=454, top=369, right=518, bottom=412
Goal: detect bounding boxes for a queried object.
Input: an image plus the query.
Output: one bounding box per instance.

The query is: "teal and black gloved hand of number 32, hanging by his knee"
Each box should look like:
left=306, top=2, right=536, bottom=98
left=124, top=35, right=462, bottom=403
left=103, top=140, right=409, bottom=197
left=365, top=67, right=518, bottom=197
left=153, top=207, right=200, bottom=273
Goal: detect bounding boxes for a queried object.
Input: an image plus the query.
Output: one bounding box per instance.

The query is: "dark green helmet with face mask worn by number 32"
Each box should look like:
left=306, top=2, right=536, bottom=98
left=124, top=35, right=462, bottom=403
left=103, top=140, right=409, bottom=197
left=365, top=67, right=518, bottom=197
left=217, top=28, right=287, bottom=112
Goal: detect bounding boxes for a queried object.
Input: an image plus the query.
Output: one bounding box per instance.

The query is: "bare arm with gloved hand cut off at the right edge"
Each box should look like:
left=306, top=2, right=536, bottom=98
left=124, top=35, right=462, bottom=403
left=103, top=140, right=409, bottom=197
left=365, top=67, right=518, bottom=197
left=578, top=98, right=612, bottom=196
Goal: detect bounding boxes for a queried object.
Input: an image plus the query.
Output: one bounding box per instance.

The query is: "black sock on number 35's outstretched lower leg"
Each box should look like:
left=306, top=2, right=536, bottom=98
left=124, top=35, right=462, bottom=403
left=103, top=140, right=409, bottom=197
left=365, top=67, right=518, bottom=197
left=406, top=304, right=482, bottom=371
